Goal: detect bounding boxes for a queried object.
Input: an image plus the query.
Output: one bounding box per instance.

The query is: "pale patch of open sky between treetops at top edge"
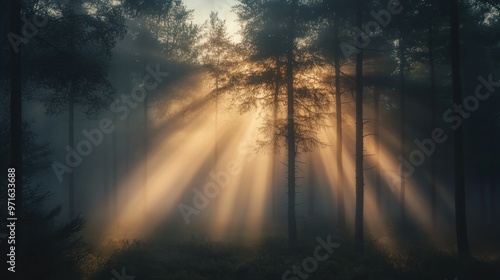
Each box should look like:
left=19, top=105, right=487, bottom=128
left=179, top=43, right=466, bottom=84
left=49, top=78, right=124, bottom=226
left=183, top=0, right=239, bottom=41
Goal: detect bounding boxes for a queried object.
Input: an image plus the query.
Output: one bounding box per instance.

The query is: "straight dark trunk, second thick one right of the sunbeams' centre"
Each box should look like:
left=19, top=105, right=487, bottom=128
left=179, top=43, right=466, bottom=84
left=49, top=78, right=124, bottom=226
left=354, top=0, right=364, bottom=251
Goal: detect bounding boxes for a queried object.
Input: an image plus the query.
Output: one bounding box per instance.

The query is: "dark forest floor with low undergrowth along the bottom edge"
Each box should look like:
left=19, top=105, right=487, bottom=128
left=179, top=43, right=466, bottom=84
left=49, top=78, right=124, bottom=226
left=86, top=223, right=500, bottom=280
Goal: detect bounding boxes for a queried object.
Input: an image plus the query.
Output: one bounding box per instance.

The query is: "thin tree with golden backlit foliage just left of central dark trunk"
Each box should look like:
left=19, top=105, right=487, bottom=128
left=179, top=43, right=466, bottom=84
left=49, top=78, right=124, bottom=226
left=235, top=1, right=286, bottom=221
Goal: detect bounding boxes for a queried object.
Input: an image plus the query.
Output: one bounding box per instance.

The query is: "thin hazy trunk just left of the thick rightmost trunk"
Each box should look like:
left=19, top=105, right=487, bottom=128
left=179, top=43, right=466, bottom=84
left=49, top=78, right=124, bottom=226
left=428, top=20, right=437, bottom=229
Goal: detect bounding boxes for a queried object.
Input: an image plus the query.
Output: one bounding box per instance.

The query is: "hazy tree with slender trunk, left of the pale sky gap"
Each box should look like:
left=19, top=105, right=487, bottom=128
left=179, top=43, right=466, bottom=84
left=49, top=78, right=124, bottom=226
left=119, top=0, right=201, bottom=217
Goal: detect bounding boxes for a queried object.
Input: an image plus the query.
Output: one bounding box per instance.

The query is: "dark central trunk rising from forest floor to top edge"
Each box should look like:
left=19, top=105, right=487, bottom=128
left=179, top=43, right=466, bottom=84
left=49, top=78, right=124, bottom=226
left=286, top=0, right=297, bottom=247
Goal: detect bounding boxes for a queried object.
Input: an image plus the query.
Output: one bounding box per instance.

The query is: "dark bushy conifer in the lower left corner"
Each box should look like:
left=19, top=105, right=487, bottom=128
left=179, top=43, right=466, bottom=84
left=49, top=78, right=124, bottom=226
left=0, top=114, right=86, bottom=279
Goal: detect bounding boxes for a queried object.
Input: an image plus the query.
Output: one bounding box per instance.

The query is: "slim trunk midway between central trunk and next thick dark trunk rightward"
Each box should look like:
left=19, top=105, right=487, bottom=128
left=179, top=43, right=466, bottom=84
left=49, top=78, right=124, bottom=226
left=333, top=13, right=345, bottom=230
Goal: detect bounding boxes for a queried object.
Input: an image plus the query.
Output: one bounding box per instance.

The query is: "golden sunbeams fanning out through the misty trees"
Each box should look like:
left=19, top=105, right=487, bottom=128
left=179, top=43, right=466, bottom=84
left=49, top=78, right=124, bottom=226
left=93, top=66, right=458, bottom=255
